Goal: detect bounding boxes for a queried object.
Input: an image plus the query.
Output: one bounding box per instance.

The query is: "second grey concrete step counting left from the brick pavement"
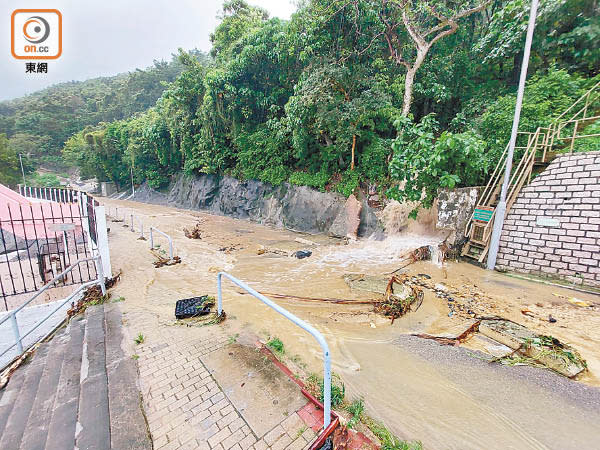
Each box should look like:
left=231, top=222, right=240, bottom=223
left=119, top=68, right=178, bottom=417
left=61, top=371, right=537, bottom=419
left=75, top=305, right=110, bottom=450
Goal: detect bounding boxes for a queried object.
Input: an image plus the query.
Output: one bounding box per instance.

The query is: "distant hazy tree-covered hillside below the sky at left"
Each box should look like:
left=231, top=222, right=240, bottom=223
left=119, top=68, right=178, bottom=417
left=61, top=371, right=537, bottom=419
left=0, top=58, right=188, bottom=166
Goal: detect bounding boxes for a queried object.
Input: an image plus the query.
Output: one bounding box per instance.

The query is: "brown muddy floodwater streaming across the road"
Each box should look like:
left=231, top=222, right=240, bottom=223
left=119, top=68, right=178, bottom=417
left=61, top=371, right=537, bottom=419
left=101, top=201, right=600, bottom=449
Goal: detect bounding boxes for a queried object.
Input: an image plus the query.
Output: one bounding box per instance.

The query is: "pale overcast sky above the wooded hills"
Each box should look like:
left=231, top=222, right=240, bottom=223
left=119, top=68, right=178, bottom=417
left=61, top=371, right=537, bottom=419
left=0, top=0, right=296, bottom=101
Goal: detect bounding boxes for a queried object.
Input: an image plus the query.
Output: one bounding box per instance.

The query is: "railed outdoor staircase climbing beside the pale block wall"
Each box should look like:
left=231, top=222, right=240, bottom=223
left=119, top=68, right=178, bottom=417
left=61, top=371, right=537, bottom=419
left=462, top=82, right=600, bottom=263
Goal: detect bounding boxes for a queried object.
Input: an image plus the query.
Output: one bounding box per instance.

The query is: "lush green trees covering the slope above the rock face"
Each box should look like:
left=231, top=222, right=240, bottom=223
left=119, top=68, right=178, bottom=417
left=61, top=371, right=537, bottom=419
left=0, top=0, right=600, bottom=206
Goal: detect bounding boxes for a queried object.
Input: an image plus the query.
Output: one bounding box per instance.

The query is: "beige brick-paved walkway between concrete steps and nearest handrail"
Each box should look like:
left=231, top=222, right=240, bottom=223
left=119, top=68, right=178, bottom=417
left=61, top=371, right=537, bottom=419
left=124, top=311, right=316, bottom=450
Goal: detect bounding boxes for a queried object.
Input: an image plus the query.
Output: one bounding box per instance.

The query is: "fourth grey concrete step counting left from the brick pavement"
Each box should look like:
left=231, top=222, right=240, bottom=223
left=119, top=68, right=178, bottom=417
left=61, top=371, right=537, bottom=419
left=20, top=327, right=69, bottom=450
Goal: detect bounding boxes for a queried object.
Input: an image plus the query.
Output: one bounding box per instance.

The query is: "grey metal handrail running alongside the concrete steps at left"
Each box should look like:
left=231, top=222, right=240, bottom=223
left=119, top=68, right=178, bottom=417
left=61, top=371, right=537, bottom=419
left=0, top=256, right=106, bottom=357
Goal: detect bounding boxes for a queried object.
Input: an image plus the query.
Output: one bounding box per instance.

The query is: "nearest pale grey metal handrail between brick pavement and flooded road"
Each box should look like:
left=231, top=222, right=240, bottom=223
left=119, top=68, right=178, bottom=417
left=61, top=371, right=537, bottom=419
left=217, top=272, right=331, bottom=428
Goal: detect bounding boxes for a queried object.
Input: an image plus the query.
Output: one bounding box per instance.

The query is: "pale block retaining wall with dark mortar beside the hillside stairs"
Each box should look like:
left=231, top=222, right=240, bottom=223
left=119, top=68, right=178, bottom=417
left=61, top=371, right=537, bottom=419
left=497, top=152, right=600, bottom=287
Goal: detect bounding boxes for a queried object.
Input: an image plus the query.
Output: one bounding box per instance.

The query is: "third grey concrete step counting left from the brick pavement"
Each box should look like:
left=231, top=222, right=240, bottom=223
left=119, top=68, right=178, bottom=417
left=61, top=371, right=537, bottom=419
left=46, top=316, right=86, bottom=450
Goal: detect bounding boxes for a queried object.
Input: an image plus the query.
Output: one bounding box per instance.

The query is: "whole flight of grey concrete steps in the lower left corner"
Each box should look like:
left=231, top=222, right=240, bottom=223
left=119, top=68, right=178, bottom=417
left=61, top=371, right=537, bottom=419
left=0, top=304, right=152, bottom=450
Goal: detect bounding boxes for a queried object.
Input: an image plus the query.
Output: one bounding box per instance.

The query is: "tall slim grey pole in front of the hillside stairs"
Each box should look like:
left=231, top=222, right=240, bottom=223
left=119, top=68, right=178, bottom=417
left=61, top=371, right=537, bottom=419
left=487, top=0, right=538, bottom=270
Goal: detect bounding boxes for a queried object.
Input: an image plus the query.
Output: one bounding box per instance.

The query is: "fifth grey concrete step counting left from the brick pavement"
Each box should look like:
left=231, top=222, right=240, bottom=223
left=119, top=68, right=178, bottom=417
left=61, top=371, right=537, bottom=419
left=0, top=345, right=49, bottom=449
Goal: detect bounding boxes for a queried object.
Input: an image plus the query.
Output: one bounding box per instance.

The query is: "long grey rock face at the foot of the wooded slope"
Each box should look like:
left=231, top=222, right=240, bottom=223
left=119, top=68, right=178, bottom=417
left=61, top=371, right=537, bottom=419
left=133, top=174, right=382, bottom=237
